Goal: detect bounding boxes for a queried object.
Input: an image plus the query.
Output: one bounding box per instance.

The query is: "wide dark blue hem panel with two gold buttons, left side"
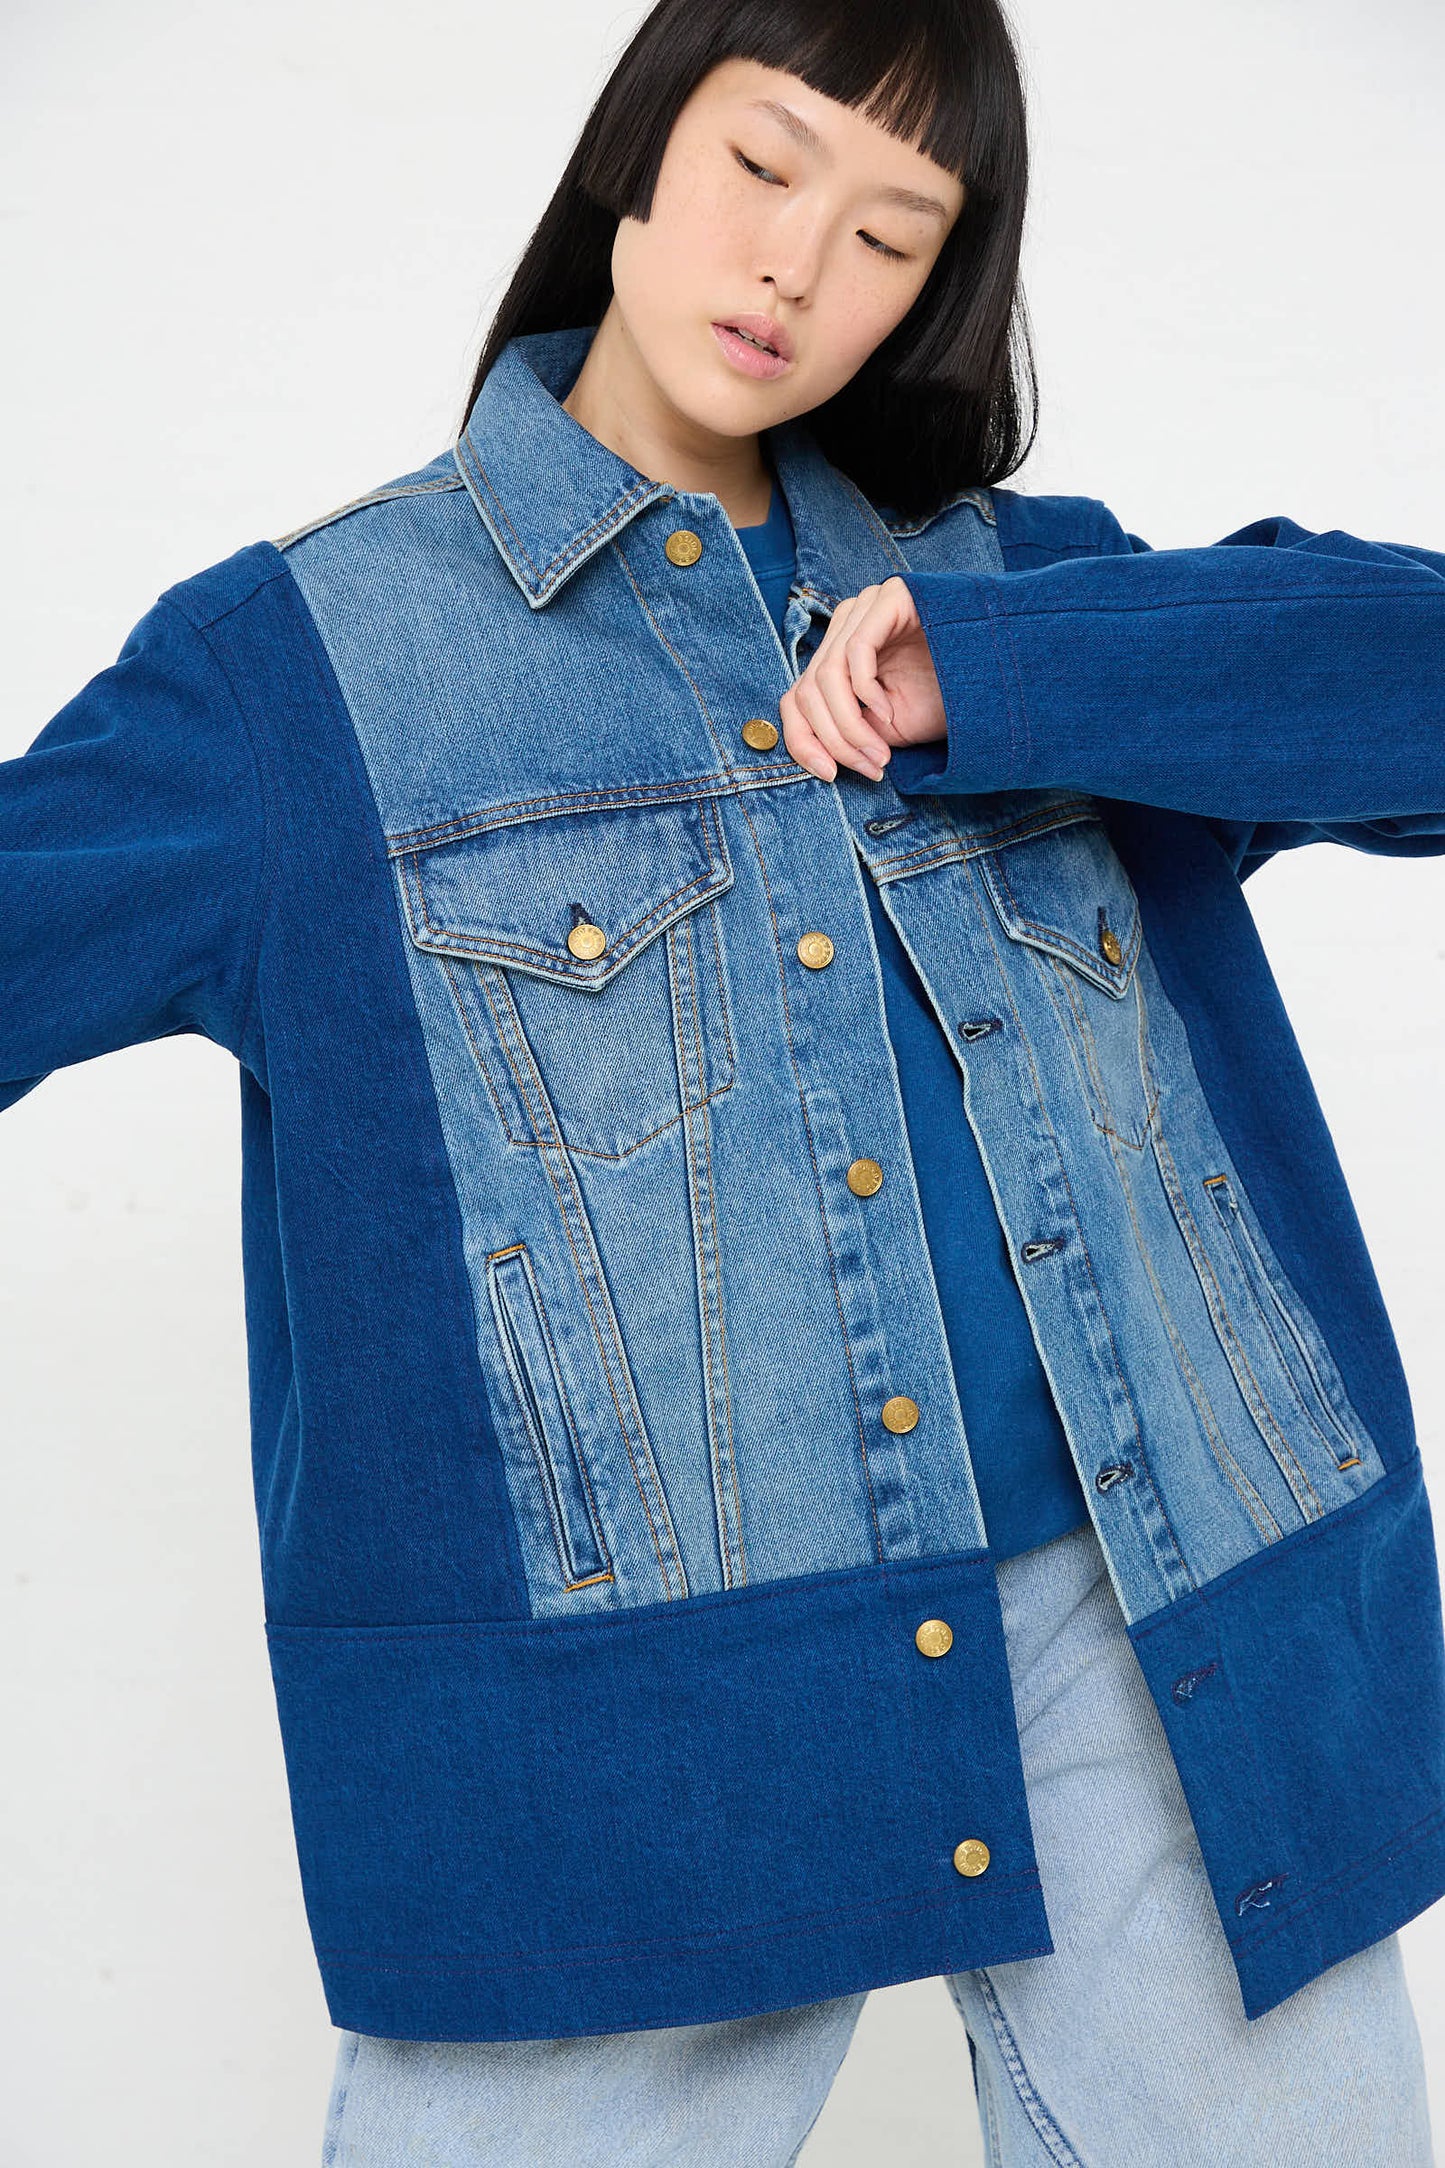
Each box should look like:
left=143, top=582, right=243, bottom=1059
left=269, top=1552, right=1051, bottom=2040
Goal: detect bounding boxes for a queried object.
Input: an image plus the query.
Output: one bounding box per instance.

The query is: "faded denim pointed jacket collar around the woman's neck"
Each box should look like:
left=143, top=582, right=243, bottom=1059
left=453, top=325, right=906, bottom=611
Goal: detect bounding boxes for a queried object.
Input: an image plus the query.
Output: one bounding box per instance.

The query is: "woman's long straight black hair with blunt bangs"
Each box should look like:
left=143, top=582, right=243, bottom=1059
left=468, top=0, right=1038, bottom=516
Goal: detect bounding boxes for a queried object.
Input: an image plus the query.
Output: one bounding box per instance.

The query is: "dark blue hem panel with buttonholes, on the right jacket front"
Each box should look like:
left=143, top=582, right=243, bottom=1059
left=1131, top=1459, right=1445, bottom=2016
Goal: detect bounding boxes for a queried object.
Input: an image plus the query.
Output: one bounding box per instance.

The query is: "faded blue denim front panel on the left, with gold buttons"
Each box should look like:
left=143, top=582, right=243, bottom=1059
left=288, top=381, right=984, bottom=1613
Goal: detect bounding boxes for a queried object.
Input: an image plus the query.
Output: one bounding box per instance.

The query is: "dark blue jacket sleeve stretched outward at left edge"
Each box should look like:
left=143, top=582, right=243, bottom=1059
left=0, top=601, right=264, bottom=1108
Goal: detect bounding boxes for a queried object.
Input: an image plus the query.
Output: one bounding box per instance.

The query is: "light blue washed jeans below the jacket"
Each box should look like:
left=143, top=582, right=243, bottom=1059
left=323, top=1526, right=1432, bottom=2168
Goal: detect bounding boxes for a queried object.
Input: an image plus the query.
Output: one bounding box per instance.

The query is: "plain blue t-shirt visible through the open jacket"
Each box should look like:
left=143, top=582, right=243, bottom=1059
left=737, top=486, right=1088, bottom=1559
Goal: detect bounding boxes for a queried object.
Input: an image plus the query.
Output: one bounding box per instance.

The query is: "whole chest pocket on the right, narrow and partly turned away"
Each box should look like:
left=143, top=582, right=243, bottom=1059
left=979, top=817, right=1157, bottom=1151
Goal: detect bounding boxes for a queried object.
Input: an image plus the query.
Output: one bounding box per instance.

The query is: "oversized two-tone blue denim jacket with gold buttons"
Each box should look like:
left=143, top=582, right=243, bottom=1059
left=0, top=316, right=1445, bottom=2040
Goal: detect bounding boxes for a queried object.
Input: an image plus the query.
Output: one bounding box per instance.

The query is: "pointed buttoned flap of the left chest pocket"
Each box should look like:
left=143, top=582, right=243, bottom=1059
left=399, top=798, right=732, bottom=989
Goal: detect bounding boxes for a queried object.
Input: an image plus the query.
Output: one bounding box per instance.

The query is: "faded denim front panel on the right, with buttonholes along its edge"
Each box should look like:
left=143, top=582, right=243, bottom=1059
left=836, top=785, right=1382, bottom=1617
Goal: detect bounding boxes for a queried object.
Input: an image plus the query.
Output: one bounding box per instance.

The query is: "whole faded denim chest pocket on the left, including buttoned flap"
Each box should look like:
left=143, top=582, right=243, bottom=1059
left=399, top=798, right=734, bottom=1160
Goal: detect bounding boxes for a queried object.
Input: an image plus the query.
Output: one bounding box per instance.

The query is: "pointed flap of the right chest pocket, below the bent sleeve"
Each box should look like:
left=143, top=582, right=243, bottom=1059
left=979, top=820, right=1142, bottom=997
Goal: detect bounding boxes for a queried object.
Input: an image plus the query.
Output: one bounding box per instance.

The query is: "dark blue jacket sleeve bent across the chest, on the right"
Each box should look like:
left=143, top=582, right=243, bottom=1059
left=888, top=505, right=1445, bottom=872
